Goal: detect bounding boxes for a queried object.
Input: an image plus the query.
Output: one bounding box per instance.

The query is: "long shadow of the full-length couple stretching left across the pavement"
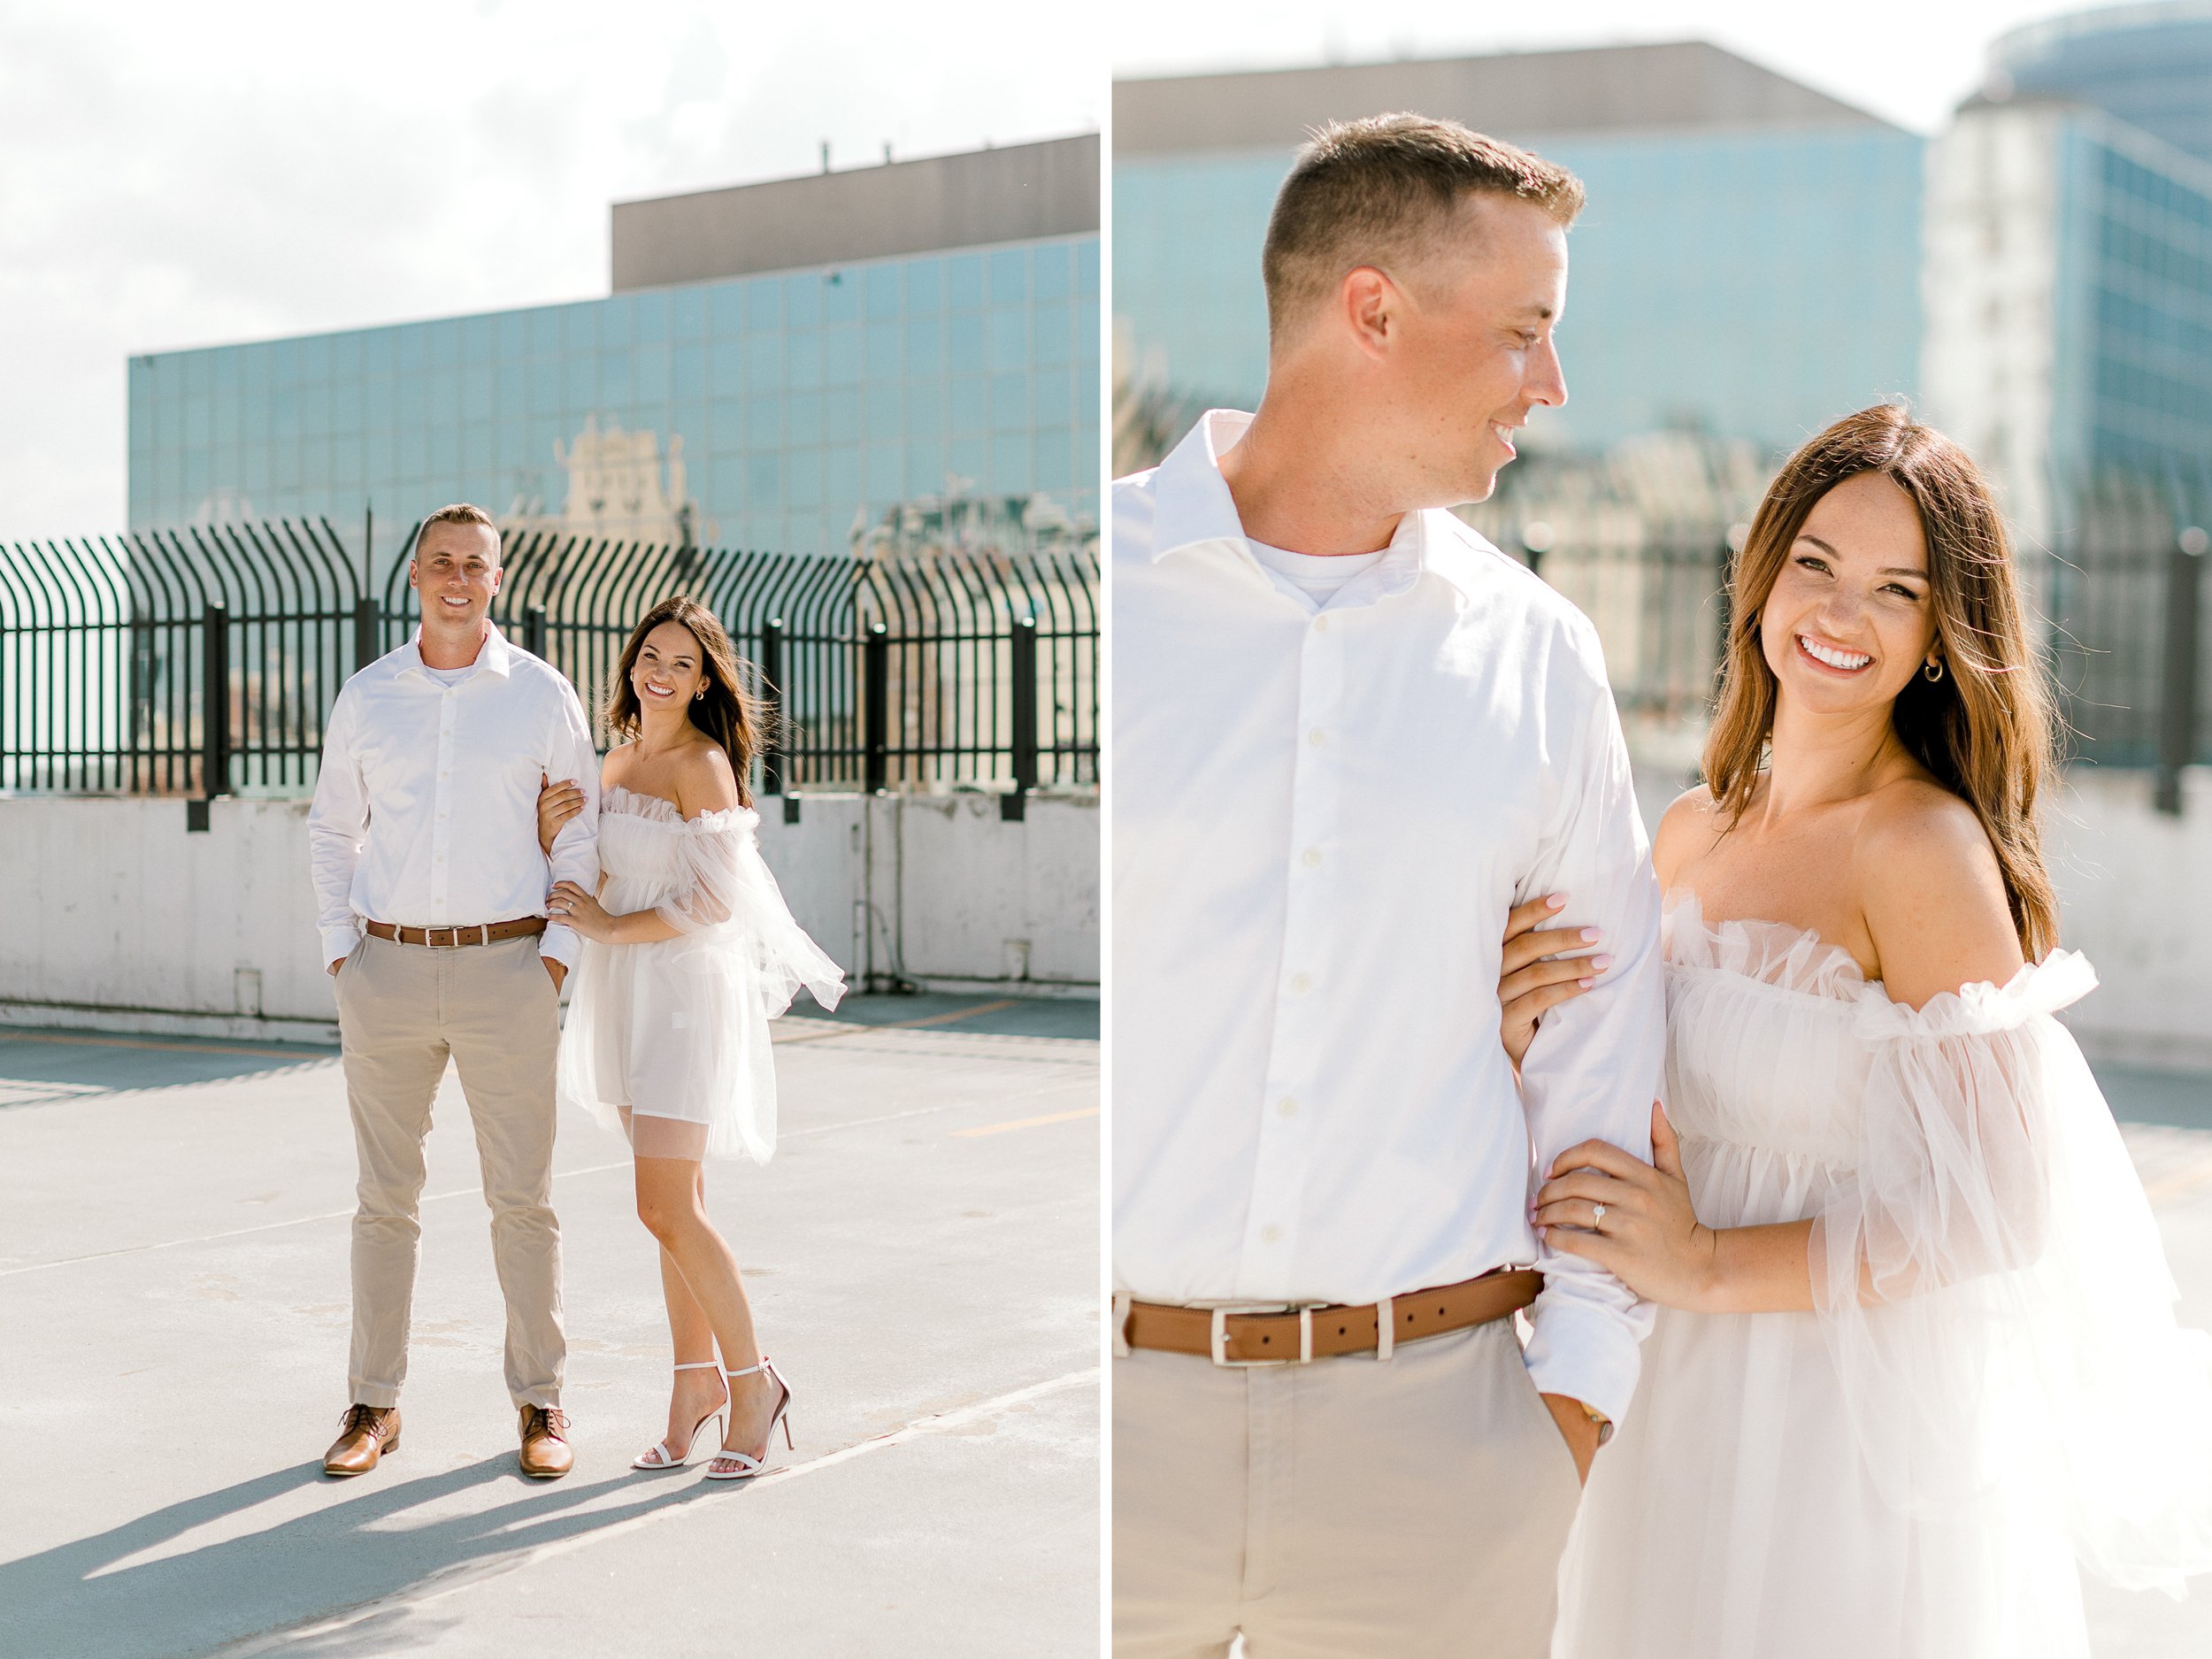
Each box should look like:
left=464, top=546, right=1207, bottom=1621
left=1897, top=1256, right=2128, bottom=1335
left=0, top=1454, right=743, bottom=1659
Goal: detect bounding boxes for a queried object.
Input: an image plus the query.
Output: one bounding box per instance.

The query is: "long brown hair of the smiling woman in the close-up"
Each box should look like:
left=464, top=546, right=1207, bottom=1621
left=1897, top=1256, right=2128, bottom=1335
left=1703, top=403, right=2060, bottom=963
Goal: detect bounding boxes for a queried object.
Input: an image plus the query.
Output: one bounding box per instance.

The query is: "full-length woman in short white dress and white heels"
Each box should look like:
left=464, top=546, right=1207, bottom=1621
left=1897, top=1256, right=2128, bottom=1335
left=538, top=597, right=843, bottom=1480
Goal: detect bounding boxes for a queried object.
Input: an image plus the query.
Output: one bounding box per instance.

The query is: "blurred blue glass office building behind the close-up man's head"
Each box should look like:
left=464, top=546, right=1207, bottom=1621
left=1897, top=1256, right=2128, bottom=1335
left=1115, top=47, right=1927, bottom=454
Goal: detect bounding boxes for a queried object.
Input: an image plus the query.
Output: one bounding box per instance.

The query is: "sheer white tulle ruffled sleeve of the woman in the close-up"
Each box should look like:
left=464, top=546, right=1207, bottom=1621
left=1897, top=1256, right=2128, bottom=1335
left=1812, top=951, right=2212, bottom=1593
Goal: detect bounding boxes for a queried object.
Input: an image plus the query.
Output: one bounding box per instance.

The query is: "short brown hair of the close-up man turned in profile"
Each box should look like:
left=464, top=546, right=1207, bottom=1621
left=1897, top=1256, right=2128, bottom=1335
left=1261, top=115, right=1582, bottom=341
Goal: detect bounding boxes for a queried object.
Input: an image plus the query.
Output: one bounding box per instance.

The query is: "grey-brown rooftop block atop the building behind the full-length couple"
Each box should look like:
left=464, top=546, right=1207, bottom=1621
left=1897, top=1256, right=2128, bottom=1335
left=613, top=133, right=1100, bottom=295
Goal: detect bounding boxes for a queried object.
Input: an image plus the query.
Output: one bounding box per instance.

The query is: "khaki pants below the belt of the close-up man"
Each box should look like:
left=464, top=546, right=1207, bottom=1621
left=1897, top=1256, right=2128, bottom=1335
left=1113, top=1318, right=1582, bottom=1659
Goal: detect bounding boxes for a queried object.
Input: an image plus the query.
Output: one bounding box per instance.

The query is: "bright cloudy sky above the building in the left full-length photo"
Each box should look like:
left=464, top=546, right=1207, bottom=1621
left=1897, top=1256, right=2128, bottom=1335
left=0, top=0, right=1109, bottom=540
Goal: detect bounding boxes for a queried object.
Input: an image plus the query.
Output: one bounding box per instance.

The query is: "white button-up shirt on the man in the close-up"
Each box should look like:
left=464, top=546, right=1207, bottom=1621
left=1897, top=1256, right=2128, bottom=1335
left=1110, top=411, right=1666, bottom=1418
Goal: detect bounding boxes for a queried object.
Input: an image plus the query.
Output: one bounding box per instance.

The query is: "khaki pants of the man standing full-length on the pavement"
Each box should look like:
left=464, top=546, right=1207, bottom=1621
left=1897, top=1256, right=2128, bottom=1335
left=336, top=936, right=569, bottom=1407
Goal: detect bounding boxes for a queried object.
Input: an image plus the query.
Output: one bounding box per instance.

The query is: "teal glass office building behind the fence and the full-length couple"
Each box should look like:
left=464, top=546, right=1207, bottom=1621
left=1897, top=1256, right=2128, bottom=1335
left=128, top=140, right=1100, bottom=556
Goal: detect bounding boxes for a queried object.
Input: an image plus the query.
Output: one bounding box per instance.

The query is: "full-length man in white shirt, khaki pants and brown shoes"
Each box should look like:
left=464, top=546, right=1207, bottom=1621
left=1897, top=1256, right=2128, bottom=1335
left=308, top=507, right=600, bottom=1478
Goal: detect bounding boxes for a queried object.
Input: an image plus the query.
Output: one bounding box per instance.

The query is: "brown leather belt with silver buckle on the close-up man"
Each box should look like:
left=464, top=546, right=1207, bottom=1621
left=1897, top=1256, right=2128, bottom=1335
left=1122, top=1268, right=1544, bottom=1365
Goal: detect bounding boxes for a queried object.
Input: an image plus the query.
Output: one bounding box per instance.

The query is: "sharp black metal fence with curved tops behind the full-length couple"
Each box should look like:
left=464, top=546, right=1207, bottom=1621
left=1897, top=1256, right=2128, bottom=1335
left=0, top=522, right=1100, bottom=817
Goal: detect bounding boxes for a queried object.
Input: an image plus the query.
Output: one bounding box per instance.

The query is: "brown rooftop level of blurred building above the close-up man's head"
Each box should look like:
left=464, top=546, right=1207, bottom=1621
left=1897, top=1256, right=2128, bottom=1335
left=1113, top=40, right=1889, bottom=157
